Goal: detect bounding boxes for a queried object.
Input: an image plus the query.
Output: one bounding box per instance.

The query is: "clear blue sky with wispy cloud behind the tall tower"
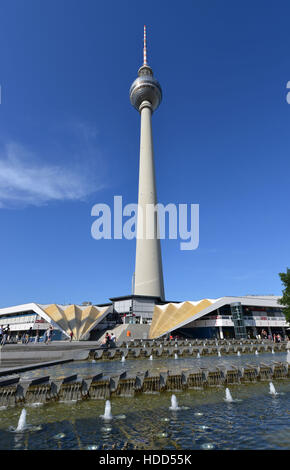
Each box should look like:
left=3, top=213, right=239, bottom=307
left=0, top=0, right=290, bottom=307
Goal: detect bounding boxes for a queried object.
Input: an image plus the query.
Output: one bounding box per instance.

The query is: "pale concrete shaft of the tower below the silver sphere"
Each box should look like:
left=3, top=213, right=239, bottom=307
left=134, top=101, right=164, bottom=299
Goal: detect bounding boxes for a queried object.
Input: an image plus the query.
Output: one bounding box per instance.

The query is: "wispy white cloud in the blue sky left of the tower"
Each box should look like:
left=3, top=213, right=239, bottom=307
left=0, top=143, right=105, bottom=207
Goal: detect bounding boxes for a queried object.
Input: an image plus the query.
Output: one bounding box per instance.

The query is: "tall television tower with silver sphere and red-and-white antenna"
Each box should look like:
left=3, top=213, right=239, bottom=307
left=130, top=26, right=164, bottom=300
